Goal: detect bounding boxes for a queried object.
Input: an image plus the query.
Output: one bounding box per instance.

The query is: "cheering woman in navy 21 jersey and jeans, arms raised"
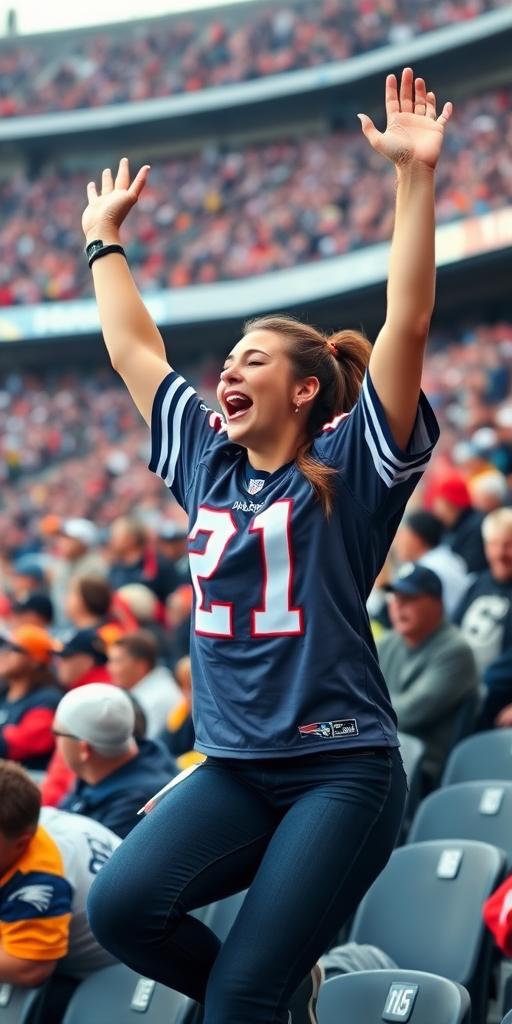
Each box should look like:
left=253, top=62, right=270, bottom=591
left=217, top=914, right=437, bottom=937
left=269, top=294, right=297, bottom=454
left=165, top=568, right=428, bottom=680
left=83, top=69, right=452, bottom=1024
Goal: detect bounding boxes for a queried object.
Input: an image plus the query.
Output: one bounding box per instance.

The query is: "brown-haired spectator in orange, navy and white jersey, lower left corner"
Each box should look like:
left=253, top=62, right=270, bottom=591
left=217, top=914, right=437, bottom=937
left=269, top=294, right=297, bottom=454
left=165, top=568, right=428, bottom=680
left=0, top=761, right=120, bottom=1007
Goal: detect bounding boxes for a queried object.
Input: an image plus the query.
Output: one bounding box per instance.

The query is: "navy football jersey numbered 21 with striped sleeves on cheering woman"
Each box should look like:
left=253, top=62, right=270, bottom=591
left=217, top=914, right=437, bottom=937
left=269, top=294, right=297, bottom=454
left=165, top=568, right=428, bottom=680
left=150, top=373, right=438, bottom=758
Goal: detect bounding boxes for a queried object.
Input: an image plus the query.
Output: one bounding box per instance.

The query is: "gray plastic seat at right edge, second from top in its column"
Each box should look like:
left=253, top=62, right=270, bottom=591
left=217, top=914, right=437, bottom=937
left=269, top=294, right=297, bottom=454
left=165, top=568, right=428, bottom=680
left=407, top=779, right=512, bottom=871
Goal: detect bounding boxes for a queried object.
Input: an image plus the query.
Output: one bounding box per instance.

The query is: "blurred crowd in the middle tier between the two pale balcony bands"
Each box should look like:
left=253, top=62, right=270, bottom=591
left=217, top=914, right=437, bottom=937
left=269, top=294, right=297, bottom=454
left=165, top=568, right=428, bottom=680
left=0, top=88, right=512, bottom=305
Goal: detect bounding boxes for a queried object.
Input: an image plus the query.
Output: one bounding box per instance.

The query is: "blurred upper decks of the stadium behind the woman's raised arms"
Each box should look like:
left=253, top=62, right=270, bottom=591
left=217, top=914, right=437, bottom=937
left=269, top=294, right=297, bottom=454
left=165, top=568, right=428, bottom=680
left=0, top=0, right=512, bottom=358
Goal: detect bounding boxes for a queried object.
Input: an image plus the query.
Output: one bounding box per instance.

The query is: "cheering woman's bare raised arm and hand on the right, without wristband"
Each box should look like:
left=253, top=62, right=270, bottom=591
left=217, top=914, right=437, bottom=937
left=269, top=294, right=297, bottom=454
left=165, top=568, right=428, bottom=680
left=359, top=68, right=452, bottom=449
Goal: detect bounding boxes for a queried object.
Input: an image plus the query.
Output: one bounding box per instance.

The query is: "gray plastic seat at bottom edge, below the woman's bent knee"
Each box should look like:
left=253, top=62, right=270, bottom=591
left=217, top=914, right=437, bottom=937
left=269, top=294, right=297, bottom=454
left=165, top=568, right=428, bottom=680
left=61, top=964, right=193, bottom=1024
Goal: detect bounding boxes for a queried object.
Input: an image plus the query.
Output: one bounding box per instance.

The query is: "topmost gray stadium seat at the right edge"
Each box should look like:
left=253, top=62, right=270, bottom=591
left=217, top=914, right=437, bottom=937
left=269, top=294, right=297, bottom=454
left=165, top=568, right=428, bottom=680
left=441, top=729, right=512, bottom=785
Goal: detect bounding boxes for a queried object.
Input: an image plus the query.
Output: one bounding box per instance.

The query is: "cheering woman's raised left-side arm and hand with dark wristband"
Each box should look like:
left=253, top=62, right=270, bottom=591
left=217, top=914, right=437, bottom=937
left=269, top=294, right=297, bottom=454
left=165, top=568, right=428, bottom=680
left=82, top=159, right=170, bottom=423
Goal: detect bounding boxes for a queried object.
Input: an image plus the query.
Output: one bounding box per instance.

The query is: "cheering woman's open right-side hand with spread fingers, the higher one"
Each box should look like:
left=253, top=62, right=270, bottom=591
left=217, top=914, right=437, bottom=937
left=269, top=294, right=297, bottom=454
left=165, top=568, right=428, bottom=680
left=358, top=68, right=452, bottom=169
